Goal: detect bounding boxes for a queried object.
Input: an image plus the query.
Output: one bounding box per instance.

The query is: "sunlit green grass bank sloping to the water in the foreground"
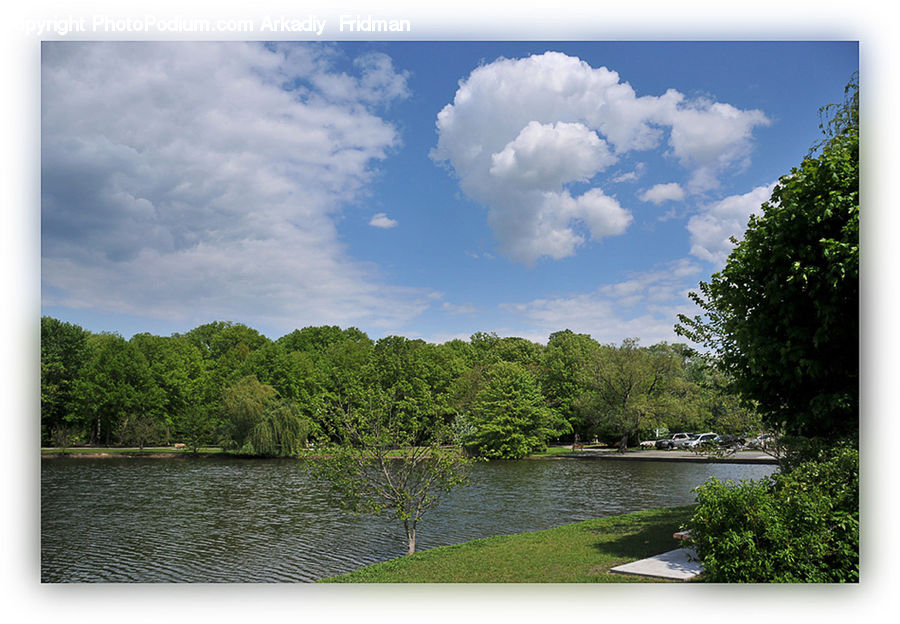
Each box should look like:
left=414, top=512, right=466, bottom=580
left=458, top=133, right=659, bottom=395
left=320, top=506, right=693, bottom=583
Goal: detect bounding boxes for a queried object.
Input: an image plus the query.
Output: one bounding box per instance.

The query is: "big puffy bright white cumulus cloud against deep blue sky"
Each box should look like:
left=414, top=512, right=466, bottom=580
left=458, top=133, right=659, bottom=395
left=432, top=52, right=768, bottom=264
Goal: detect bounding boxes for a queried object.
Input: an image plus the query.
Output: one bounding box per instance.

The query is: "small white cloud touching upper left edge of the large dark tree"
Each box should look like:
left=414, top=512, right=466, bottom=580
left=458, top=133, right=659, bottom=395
left=687, top=183, right=775, bottom=267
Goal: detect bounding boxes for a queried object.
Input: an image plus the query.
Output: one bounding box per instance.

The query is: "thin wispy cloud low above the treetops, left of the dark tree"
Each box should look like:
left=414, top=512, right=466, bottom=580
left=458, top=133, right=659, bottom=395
left=503, top=259, right=704, bottom=344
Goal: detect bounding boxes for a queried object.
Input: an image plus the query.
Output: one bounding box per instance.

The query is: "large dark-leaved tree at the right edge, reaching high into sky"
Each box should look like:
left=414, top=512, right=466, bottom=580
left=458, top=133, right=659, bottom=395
left=676, top=75, right=859, bottom=439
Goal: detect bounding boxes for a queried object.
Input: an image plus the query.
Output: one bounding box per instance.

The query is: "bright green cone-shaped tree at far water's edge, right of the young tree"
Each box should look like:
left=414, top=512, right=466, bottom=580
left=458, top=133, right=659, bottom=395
left=465, top=361, right=570, bottom=459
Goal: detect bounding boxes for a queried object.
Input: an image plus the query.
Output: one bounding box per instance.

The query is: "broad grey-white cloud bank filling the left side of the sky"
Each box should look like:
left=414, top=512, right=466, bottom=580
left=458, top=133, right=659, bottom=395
left=42, top=43, right=428, bottom=330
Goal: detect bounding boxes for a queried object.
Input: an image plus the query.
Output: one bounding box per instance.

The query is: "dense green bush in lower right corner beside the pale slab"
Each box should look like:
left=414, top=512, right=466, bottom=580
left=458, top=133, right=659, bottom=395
left=688, top=448, right=859, bottom=583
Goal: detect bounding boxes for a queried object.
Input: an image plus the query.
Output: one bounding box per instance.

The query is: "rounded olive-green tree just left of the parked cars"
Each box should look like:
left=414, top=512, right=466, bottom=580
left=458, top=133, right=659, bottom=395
left=579, top=338, right=681, bottom=451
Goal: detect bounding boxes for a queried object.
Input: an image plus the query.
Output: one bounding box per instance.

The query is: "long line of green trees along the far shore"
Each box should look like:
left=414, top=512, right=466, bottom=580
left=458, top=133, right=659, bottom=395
left=41, top=316, right=761, bottom=458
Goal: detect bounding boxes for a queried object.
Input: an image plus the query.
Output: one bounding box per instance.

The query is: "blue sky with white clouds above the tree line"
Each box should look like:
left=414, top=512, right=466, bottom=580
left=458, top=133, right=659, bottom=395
left=40, top=41, right=859, bottom=344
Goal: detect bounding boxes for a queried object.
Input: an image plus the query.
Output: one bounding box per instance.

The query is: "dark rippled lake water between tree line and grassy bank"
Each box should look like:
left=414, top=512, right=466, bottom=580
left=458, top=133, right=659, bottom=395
left=41, top=458, right=773, bottom=583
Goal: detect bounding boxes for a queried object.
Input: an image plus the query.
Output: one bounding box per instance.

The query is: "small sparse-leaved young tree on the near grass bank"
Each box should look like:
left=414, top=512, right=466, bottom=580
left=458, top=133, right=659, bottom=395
left=310, top=387, right=470, bottom=554
